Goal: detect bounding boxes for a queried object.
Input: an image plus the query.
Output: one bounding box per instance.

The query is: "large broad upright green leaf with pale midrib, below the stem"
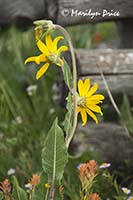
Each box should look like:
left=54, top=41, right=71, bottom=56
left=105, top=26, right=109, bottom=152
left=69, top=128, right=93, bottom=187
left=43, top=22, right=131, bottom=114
left=42, top=119, right=68, bottom=183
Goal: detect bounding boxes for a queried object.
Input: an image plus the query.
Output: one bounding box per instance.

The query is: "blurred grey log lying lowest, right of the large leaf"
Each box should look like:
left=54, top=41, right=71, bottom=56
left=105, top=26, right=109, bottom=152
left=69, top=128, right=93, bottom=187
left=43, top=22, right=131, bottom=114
left=72, top=121, right=133, bottom=170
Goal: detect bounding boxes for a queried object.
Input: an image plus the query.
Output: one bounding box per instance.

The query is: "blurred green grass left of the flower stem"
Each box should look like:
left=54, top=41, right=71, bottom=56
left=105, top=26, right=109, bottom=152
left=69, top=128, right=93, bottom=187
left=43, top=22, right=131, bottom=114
left=0, top=27, right=60, bottom=181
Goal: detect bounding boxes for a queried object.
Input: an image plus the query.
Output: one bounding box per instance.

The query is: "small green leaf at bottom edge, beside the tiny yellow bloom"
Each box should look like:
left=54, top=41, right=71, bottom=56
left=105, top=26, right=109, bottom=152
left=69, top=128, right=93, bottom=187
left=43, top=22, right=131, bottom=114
left=32, top=172, right=48, bottom=200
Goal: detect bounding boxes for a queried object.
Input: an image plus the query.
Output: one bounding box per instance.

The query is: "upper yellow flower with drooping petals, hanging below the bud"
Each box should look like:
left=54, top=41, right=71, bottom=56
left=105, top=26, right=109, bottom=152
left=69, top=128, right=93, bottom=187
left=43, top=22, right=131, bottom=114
left=25, top=35, right=68, bottom=80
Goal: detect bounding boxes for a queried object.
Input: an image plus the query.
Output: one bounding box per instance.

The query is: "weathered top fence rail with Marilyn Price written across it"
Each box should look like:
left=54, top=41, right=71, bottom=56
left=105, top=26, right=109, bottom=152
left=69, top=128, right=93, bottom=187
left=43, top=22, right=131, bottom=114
left=57, top=0, right=133, bottom=26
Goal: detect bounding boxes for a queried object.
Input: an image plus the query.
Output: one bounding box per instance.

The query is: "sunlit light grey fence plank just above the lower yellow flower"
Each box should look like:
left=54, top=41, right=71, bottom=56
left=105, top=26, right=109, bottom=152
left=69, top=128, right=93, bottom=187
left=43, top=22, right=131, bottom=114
left=76, top=49, right=133, bottom=75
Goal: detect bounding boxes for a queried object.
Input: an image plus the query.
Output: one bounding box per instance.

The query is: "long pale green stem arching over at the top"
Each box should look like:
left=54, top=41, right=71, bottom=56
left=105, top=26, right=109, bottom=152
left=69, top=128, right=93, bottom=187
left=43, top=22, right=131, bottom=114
left=55, top=25, right=77, bottom=148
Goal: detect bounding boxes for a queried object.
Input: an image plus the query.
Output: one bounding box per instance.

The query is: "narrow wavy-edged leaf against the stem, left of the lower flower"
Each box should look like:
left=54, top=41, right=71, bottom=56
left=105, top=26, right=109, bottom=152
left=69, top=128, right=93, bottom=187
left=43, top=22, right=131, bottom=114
left=64, top=92, right=73, bottom=138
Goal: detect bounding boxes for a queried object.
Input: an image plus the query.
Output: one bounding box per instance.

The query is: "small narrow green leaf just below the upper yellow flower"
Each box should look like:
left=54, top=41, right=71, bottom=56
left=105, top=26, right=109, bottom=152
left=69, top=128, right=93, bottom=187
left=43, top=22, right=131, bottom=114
left=63, top=59, right=72, bottom=90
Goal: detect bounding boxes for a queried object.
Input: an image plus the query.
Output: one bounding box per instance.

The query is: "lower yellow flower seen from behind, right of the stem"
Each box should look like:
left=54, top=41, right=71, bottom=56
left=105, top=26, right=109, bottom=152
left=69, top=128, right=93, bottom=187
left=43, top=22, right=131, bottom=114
left=77, top=79, right=104, bottom=126
